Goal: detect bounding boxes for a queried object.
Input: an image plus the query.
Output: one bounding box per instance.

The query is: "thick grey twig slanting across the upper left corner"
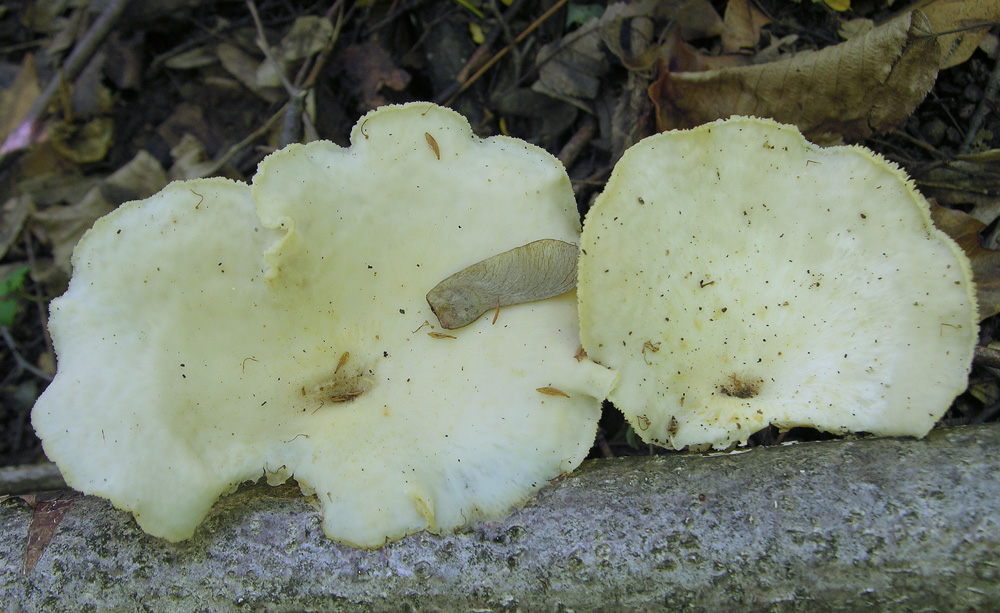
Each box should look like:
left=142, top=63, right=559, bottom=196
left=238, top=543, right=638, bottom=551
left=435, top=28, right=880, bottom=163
left=0, top=0, right=129, bottom=156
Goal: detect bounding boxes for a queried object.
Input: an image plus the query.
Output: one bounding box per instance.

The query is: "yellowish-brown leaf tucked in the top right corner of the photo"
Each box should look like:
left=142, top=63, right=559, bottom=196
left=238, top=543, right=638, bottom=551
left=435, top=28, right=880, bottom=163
left=911, top=0, right=1000, bottom=69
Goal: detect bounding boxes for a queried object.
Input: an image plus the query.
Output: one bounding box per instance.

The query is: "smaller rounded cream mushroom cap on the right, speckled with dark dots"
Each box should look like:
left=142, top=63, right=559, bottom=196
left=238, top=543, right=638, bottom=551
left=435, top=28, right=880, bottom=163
left=577, top=118, right=977, bottom=449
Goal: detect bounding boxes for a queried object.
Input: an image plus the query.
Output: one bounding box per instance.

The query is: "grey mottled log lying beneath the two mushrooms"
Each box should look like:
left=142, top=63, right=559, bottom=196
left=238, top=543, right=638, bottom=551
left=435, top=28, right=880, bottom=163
left=0, top=424, right=1000, bottom=611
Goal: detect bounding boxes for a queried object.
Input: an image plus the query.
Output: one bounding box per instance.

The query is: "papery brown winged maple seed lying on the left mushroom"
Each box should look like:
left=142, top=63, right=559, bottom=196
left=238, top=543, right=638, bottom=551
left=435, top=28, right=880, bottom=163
left=427, top=238, right=579, bottom=330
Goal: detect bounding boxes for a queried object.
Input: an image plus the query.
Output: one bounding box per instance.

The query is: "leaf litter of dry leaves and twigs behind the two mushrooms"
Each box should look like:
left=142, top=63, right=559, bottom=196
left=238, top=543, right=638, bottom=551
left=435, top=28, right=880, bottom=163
left=0, top=0, right=1000, bottom=478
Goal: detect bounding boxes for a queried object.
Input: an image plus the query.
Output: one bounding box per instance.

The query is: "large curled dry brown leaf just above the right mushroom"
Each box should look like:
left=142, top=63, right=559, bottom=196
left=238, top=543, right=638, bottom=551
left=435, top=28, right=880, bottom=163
left=650, top=11, right=940, bottom=144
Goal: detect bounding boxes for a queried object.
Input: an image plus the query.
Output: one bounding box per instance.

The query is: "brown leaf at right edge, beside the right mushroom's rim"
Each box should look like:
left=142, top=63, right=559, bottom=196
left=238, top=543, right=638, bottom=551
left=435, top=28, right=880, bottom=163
left=931, top=202, right=1000, bottom=321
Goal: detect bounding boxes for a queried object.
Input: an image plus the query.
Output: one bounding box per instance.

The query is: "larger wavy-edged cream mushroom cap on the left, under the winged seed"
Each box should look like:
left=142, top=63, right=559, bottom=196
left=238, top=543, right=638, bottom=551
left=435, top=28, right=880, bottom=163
left=32, top=104, right=615, bottom=547
